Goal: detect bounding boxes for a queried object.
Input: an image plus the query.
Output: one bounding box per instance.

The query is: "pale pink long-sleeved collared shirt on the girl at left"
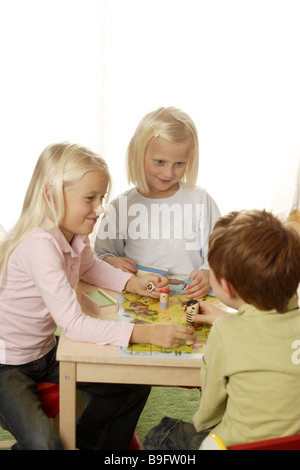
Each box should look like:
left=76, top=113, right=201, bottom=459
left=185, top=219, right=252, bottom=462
left=0, top=229, right=133, bottom=365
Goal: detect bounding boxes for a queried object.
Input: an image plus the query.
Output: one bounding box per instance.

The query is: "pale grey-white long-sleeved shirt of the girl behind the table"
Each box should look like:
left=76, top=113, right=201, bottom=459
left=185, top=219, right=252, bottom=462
left=95, top=184, right=220, bottom=275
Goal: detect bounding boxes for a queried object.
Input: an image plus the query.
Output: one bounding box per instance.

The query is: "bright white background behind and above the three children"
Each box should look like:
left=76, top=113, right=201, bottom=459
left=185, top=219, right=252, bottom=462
left=0, top=0, right=300, bottom=229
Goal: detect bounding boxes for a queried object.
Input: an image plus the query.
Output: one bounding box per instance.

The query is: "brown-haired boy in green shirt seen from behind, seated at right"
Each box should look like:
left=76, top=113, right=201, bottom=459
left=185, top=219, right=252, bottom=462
left=145, top=210, right=300, bottom=450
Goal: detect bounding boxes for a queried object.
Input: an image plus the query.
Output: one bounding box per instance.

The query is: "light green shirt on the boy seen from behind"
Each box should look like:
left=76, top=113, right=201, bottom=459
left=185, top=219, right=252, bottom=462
left=194, top=298, right=300, bottom=446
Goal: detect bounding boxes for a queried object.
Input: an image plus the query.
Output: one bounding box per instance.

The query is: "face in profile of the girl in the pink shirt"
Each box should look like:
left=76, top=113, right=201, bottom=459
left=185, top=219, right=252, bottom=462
left=59, top=170, right=108, bottom=243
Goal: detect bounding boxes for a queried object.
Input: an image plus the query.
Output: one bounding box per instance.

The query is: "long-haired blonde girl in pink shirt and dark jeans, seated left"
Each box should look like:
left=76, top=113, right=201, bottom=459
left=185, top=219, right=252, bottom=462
left=0, top=143, right=195, bottom=450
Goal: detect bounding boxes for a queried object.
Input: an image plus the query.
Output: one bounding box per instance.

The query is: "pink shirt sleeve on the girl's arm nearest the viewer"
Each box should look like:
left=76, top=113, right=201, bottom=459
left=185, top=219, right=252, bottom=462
left=22, top=238, right=133, bottom=347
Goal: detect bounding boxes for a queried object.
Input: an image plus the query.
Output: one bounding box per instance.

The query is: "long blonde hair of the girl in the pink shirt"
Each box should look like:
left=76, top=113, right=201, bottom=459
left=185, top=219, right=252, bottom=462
left=0, top=142, right=111, bottom=287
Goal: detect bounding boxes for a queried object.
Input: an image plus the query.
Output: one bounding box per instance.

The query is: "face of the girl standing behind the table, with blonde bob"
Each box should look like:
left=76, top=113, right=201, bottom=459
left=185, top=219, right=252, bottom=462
left=144, top=137, right=192, bottom=199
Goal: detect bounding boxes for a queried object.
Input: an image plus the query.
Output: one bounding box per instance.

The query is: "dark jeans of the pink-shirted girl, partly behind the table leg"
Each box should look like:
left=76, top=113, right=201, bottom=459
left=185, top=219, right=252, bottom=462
left=0, top=347, right=151, bottom=450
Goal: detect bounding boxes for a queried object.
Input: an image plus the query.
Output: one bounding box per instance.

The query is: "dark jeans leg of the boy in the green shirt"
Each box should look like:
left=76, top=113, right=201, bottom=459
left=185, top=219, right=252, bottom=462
left=144, top=417, right=209, bottom=450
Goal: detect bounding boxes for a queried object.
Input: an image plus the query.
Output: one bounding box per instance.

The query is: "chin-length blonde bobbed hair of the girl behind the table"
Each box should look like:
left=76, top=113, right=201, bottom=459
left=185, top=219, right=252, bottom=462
left=126, top=107, right=199, bottom=194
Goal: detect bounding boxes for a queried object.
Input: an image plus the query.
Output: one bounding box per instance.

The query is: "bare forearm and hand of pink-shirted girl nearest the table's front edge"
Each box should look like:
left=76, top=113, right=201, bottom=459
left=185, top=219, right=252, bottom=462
left=130, top=323, right=196, bottom=348
